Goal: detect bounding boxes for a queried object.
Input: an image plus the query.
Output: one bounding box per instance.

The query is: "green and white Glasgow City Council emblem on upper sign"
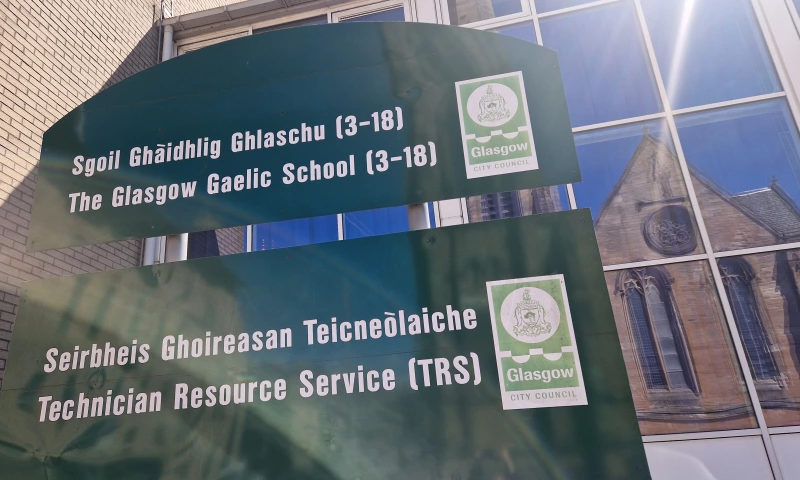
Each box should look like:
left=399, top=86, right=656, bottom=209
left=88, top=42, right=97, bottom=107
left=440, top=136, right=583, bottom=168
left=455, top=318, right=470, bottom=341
left=456, top=72, right=539, bottom=178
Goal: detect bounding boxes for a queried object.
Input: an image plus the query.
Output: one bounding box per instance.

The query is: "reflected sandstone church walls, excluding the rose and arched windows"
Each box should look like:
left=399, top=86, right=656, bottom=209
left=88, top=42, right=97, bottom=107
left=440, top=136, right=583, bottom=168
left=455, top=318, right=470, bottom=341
left=595, top=134, right=800, bottom=435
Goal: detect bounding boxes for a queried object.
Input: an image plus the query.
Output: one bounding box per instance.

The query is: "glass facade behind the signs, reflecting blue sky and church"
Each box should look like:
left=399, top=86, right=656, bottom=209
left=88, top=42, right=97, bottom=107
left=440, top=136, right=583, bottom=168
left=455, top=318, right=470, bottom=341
left=178, top=0, right=800, bottom=472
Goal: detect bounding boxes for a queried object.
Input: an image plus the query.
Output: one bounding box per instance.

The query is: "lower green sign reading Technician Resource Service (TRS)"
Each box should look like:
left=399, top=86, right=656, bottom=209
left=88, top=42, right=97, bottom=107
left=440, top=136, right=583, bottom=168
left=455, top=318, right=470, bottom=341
left=0, top=210, right=650, bottom=480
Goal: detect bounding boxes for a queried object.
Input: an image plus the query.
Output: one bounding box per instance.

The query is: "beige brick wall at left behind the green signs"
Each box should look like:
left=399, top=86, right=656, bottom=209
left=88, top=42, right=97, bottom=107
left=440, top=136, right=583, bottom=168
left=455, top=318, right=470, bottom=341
left=0, top=0, right=238, bottom=381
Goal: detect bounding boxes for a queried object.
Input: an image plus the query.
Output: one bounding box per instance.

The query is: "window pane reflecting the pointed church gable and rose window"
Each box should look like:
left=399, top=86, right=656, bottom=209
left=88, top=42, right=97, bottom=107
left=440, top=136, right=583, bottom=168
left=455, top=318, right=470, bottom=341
left=572, top=121, right=703, bottom=265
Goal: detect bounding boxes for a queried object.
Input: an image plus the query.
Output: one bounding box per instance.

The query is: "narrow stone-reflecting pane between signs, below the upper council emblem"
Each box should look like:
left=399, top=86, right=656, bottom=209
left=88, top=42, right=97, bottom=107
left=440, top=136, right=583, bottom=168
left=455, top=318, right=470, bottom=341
left=467, top=185, right=569, bottom=222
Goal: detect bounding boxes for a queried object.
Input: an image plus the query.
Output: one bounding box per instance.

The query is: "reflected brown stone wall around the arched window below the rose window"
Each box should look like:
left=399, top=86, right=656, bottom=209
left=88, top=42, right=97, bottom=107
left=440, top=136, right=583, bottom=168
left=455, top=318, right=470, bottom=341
left=606, top=262, right=756, bottom=435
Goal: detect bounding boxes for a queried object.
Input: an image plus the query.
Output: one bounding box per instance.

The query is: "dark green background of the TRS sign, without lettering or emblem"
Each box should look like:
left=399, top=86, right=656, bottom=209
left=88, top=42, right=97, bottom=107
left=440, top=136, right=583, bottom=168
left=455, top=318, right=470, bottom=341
left=0, top=210, right=650, bottom=480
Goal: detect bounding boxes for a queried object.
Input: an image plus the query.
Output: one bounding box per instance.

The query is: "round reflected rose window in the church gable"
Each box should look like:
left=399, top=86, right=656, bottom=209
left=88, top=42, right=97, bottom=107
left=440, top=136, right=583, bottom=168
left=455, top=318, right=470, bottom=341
left=644, top=205, right=697, bottom=255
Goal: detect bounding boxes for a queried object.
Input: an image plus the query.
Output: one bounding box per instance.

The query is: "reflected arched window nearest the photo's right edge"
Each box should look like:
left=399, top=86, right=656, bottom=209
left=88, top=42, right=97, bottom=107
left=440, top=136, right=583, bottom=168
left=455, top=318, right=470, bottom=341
left=719, top=258, right=778, bottom=381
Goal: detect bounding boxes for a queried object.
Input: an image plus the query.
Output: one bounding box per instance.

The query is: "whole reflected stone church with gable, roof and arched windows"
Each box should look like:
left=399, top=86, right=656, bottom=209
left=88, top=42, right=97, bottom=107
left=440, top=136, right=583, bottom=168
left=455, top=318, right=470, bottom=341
left=467, top=129, right=800, bottom=435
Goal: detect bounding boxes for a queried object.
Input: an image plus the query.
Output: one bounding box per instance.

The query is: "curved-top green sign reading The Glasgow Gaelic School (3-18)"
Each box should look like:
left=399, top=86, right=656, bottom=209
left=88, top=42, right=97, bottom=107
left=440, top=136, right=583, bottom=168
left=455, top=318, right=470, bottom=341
left=28, top=23, right=580, bottom=251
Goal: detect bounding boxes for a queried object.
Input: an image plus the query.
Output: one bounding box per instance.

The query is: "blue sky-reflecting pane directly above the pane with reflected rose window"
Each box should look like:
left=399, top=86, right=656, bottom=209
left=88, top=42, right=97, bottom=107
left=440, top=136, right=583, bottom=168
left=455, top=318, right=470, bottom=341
left=539, top=2, right=661, bottom=126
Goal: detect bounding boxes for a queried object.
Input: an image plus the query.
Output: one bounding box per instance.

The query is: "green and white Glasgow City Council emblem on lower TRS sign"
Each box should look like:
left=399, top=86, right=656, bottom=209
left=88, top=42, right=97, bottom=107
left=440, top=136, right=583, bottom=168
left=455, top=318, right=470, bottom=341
left=486, top=275, right=588, bottom=410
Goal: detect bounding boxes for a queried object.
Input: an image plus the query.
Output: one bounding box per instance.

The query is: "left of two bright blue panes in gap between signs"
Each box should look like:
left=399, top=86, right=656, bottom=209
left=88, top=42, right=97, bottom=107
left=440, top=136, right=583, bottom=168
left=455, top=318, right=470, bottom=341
left=253, top=215, right=339, bottom=251
